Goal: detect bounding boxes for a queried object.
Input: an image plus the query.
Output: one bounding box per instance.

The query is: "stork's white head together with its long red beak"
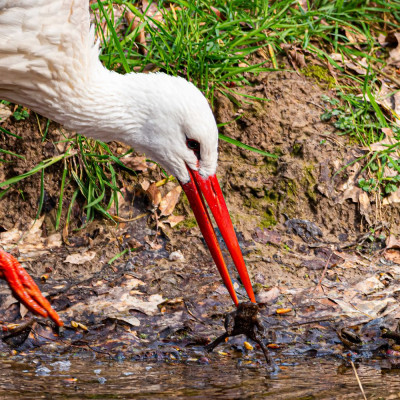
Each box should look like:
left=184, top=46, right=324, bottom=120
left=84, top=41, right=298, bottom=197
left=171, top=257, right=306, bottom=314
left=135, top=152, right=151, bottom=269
left=126, top=74, right=255, bottom=304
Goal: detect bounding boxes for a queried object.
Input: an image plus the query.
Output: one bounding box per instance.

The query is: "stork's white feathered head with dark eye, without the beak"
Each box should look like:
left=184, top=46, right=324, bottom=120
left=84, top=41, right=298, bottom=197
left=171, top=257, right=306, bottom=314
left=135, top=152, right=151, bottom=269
left=135, top=73, right=218, bottom=183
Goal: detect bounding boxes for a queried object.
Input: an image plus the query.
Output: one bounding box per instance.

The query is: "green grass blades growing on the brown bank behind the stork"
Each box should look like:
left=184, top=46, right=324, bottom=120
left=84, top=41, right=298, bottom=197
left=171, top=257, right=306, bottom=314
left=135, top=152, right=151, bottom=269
left=0, top=0, right=400, bottom=227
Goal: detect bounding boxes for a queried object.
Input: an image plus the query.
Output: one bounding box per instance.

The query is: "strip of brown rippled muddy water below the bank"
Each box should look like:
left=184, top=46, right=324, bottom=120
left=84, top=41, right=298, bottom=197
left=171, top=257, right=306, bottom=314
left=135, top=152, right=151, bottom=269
left=0, top=356, right=400, bottom=399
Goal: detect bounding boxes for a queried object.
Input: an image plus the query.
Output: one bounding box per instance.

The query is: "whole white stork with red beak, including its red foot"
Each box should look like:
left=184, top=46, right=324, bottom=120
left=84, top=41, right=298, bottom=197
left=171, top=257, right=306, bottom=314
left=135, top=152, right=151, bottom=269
left=0, top=0, right=255, bottom=326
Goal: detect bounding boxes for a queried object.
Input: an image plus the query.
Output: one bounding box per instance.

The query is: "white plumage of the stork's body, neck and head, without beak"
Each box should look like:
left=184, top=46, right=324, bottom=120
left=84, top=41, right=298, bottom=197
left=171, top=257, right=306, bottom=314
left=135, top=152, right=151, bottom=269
left=0, top=0, right=218, bottom=183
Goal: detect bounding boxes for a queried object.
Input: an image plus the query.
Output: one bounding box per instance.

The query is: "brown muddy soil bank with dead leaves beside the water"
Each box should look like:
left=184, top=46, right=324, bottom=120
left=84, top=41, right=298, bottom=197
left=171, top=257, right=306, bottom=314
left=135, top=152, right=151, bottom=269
left=0, top=68, right=400, bottom=368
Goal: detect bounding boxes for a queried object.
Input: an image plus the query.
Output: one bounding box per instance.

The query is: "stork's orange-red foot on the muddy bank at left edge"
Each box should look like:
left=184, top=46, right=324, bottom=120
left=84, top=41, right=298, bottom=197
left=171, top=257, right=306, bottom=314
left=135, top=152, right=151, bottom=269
left=0, top=249, right=64, bottom=326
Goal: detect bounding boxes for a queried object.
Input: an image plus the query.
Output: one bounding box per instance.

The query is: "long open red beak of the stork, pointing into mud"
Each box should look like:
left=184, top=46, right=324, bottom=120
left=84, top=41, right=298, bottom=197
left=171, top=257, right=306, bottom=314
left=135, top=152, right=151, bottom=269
left=181, top=167, right=256, bottom=305
